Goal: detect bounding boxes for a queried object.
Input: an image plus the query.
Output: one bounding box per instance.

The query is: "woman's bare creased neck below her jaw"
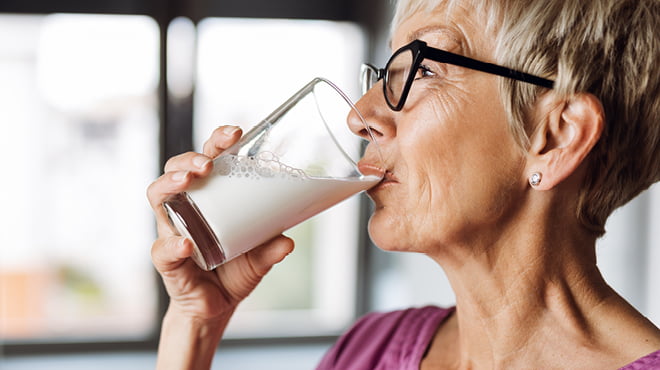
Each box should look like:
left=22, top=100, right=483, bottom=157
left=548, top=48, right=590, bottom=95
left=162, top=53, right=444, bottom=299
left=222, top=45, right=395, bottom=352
left=433, top=204, right=617, bottom=368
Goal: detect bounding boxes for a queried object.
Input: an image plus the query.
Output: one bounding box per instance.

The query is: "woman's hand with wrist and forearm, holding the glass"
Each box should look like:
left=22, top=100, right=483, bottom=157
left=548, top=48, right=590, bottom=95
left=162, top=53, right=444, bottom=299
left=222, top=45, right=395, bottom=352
left=147, top=126, right=293, bottom=370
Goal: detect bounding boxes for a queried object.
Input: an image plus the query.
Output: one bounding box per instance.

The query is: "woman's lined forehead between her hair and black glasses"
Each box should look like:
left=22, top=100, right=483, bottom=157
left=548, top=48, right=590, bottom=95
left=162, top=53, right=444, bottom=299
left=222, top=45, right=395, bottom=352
left=391, top=1, right=486, bottom=54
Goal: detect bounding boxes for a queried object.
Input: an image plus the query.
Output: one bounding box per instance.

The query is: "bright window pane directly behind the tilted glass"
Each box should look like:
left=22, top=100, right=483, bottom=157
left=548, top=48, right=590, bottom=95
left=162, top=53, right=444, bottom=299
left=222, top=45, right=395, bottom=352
left=194, top=18, right=364, bottom=337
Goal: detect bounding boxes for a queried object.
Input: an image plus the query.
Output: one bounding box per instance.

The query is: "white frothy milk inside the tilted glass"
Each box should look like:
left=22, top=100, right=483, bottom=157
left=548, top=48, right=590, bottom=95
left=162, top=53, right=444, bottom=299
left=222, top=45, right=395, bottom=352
left=187, top=155, right=380, bottom=260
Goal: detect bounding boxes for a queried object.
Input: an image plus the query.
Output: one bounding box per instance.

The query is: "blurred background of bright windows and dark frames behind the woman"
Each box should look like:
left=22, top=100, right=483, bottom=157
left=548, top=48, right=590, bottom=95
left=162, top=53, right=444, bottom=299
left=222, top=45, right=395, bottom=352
left=0, top=0, right=660, bottom=370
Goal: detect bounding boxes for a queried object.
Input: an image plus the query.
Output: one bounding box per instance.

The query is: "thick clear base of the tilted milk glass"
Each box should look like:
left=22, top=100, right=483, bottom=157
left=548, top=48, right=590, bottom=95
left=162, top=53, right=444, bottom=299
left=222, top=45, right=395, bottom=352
left=163, top=193, right=226, bottom=271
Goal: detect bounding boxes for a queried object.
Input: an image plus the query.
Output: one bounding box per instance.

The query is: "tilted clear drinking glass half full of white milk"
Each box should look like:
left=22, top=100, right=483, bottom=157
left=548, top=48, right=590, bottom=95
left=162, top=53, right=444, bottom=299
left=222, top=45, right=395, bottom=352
left=163, top=78, right=383, bottom=270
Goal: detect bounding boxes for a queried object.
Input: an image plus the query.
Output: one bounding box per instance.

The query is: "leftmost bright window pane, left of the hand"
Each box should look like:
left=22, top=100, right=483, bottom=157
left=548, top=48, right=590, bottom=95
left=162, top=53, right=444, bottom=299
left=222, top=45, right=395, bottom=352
left=0, top=14, right=159, bottom=341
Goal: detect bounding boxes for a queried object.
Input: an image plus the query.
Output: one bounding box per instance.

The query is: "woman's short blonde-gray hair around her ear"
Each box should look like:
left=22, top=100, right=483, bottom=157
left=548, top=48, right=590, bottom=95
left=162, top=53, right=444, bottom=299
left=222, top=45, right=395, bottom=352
left=393, top=0, right=660, bottom=235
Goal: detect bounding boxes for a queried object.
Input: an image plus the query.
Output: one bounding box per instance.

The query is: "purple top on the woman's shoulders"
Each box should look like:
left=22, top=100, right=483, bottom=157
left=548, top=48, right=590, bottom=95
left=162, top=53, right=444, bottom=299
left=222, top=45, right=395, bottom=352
left=316, top=306, right=660, bottom=370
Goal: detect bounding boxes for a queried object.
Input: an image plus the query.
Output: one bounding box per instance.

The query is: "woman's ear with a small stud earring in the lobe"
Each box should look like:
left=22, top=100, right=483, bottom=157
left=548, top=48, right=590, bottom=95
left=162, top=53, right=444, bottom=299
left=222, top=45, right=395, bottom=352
left=526, top=93, right=605, bottom=190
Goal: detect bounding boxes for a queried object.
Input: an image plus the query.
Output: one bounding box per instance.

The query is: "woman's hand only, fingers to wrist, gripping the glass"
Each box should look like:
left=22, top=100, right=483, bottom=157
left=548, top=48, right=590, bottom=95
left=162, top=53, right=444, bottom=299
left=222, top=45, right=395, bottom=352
left=147, top=126, right=293, bottom=329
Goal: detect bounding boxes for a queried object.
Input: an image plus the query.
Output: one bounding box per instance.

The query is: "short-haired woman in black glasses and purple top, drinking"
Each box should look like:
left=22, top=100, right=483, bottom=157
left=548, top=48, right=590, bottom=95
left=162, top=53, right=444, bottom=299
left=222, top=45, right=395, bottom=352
left=148, top=0, right=660, bottom=369
